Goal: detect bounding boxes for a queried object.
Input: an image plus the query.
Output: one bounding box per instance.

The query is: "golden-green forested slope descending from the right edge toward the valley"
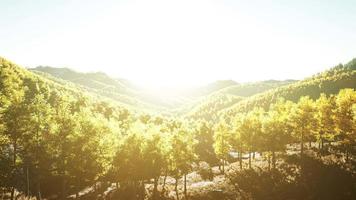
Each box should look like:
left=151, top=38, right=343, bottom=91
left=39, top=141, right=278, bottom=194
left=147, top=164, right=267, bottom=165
left=223, top=58, right=356, bottom=118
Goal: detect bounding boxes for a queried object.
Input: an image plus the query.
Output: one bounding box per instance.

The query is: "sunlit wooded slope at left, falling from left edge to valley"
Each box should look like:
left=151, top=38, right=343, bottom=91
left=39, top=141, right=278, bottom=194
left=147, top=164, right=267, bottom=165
left=0, top=57, right=145, bottom=121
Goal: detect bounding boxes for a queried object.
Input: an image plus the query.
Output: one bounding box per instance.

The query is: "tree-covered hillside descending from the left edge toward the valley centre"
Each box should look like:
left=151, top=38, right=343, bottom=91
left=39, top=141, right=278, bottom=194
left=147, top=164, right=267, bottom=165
left=0, top=57, right=138, bottom=119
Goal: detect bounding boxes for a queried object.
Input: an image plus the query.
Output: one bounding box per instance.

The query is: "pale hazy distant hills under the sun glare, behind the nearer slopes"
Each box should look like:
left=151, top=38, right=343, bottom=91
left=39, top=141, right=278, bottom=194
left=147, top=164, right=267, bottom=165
left=30, top=66, right=293, bottom=114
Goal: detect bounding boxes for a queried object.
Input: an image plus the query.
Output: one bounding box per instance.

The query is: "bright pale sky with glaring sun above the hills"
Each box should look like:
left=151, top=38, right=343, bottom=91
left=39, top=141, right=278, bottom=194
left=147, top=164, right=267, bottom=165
left=0, top=0, right=356, bottom=88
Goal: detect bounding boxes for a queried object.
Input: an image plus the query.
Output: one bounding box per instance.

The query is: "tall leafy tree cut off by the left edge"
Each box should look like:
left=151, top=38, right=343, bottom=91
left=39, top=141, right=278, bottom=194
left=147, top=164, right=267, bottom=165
left=0, top=57, right=26, bottom=199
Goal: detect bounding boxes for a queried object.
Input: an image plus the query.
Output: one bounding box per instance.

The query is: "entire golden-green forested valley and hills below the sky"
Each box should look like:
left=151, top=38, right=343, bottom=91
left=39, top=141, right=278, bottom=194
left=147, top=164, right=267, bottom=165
left=0, top=58, right=356, bottom=200
